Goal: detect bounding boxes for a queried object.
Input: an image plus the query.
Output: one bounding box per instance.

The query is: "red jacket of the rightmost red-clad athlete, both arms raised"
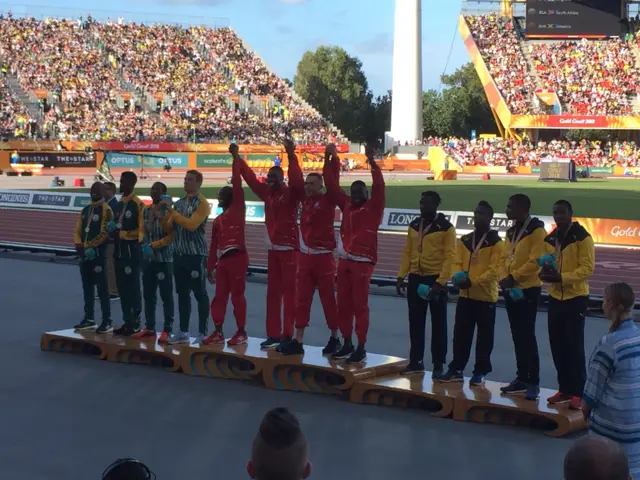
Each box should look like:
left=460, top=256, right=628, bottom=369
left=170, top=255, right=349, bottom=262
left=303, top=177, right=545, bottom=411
left=325, top=160, right=385, bottom=264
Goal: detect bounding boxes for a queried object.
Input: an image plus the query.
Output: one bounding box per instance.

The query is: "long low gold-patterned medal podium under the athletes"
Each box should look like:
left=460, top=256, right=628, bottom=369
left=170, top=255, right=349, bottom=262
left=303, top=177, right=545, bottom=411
left=40, top=330, right=586, bottom=437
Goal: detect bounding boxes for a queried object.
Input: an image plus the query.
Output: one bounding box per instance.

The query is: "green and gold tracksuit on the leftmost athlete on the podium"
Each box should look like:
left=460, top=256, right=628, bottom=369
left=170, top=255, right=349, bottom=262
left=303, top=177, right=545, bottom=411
left=73, top=200, right=113, bottom=324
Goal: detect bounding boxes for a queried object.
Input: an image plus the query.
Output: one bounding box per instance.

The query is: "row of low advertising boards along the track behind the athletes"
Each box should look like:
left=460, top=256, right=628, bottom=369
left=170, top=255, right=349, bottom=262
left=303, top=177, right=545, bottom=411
left=0, top=190, right=640, bottom=248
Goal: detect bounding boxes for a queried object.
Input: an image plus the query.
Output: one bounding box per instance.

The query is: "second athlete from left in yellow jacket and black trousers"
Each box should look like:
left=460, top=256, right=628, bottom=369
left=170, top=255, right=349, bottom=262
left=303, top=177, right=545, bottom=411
left=439, top=201, right=504, bottom=385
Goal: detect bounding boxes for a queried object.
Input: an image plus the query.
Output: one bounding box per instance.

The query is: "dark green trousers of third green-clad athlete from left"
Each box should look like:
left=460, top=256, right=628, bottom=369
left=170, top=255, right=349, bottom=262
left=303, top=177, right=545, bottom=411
left=142, top=262, right=174, bottom=333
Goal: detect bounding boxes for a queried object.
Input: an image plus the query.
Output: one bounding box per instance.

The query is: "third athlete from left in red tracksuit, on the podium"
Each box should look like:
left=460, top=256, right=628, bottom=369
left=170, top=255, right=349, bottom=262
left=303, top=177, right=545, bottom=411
left=279, top=145, right=342, bottom=355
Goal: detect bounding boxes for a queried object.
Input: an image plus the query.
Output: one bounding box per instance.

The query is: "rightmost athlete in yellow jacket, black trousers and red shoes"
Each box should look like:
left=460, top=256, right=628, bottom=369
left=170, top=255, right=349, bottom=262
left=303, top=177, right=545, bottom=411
left=540, top=200, right=595, bottom=409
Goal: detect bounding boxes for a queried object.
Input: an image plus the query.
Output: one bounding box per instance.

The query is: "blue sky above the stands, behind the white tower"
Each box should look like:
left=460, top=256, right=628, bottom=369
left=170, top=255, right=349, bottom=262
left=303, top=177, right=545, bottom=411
left=7, top=0, right=469, bottom=94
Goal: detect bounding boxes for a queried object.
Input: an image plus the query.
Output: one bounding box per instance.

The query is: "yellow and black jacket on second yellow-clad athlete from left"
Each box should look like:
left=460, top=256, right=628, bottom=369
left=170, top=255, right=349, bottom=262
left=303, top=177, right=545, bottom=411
left=453, top=230, right=504, bottom=303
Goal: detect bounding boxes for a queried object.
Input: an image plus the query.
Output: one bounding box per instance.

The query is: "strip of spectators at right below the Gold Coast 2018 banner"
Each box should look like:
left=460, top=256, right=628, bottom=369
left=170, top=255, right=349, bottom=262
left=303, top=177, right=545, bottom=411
left=436, top=138, right=640, bottom=168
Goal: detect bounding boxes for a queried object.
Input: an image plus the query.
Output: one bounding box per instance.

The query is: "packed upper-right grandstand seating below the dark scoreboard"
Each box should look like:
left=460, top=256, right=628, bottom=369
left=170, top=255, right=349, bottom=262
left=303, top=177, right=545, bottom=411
left=466, top=15, right=640, bottom=115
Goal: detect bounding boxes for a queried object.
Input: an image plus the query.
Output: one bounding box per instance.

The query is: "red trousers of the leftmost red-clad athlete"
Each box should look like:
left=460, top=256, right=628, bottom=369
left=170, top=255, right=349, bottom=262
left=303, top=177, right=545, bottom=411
left=211, top=252, right=249, bottom=330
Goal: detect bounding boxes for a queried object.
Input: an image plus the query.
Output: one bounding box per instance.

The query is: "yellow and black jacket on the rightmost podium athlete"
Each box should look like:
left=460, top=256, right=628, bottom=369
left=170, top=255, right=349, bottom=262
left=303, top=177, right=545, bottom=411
left=543, top=222, right=596, bottom=300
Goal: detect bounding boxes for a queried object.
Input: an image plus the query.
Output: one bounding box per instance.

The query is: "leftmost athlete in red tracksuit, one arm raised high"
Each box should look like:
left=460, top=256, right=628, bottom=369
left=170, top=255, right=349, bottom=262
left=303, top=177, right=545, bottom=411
left=203, top=144, right=249, bottom=345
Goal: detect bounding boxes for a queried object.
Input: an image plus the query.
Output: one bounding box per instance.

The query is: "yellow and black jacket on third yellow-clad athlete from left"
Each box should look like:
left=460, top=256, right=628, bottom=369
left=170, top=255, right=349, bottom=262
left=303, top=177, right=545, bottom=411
left=502, top=218, right=547, bottom=290
